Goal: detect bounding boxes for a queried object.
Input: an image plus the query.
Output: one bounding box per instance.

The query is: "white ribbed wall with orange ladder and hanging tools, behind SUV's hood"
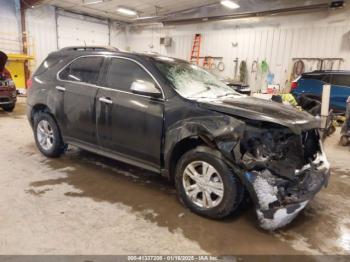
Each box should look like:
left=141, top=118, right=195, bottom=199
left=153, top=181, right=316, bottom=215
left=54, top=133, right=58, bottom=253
left=127, top=9, right=350, bottom=90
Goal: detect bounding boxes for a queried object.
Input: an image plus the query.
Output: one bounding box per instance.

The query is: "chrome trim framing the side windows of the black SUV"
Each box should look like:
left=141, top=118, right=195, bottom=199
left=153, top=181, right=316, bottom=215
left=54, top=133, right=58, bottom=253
left=56, top=55, right=165, bottom=101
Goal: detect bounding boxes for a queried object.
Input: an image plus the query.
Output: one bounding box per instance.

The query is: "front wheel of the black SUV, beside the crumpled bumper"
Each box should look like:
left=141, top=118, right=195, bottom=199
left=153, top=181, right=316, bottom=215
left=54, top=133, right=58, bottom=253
left=175, top=148, right=244, bottom=219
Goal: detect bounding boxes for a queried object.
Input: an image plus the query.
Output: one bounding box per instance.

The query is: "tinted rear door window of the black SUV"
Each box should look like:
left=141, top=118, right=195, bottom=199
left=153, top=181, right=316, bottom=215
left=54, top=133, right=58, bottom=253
left=59, top=56, right=103, bottom=84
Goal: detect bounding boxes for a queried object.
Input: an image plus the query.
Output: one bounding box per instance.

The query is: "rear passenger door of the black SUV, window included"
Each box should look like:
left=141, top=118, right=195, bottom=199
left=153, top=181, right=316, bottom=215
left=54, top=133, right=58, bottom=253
left=56, top=56, right=104, bottom=144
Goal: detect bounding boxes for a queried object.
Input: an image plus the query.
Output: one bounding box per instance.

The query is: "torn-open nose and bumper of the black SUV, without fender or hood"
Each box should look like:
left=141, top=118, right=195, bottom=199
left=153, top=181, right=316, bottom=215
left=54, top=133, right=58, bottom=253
left=235, top=122, right=330, bottom=230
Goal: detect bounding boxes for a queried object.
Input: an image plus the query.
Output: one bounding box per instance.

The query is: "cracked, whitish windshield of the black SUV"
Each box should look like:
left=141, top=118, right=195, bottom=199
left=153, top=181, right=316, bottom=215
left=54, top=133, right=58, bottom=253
left=155, top=59, right=240, bottom=99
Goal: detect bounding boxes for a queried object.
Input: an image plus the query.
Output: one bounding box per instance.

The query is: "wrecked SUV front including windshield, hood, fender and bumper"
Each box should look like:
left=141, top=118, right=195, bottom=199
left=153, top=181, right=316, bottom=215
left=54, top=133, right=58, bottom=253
left=157, top=56, right=330, bottom=230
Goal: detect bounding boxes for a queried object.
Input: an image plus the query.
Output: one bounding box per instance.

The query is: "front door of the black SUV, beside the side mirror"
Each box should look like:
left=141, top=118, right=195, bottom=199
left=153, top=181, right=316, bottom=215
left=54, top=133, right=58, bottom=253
left=96, top=57, right=164, bottom=170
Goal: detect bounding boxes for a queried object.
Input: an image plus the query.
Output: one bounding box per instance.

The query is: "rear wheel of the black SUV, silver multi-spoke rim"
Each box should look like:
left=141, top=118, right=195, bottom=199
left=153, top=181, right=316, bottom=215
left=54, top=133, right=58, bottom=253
left=34, top=112, right=66, bottom=158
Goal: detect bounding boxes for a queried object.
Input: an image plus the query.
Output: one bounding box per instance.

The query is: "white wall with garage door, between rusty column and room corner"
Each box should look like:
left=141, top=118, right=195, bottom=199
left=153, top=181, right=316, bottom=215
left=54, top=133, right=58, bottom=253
left=25, top=6, right=126, bottom=70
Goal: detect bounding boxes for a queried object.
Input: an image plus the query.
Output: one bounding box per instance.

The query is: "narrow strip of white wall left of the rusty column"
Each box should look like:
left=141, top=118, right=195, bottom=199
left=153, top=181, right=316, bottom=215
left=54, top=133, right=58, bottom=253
left=0, top=0, right=22, bottom=53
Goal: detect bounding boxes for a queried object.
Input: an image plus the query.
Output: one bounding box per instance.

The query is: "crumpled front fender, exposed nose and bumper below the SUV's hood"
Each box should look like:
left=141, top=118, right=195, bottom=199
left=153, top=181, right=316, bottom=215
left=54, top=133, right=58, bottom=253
left=165, top=115, right=329, bottom=230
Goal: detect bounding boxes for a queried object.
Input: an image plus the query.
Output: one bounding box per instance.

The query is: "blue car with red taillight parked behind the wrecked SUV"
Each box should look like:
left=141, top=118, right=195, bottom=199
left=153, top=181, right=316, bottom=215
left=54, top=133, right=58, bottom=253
left=291, top=71, right=350, bottom=112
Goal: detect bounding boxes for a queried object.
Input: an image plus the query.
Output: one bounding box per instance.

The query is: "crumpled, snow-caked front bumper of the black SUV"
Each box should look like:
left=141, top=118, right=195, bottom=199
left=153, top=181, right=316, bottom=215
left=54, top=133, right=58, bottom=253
left=244, top=142, right=330, bottom=230
